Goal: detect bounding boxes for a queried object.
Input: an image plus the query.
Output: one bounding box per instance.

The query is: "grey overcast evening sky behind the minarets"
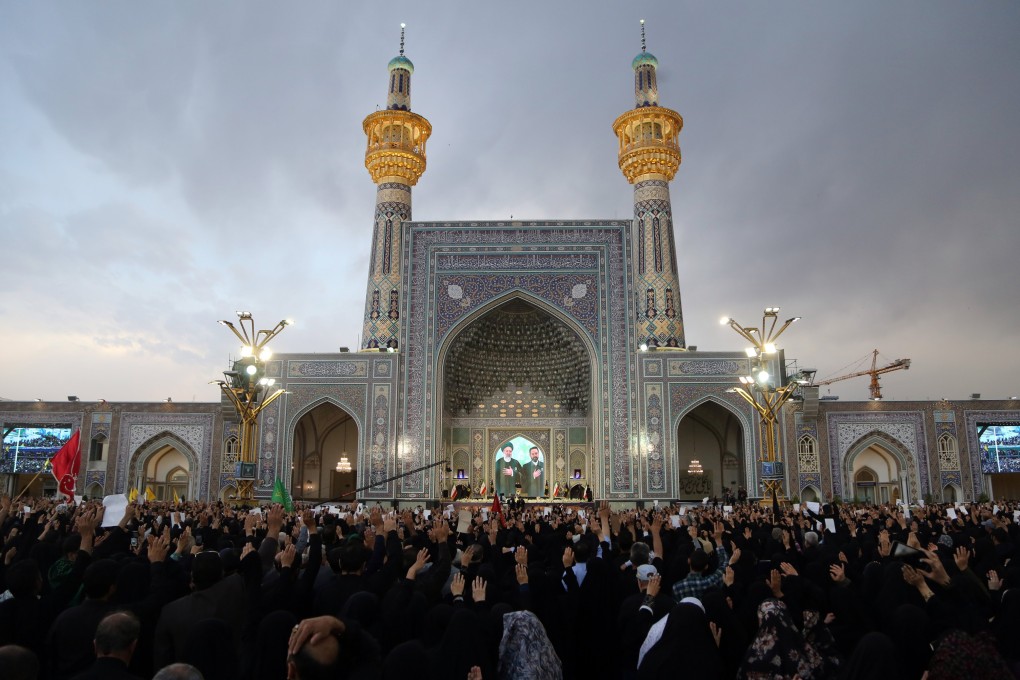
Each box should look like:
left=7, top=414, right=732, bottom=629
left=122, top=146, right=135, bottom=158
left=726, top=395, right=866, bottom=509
left=0, top=0, right=1020, bottom=402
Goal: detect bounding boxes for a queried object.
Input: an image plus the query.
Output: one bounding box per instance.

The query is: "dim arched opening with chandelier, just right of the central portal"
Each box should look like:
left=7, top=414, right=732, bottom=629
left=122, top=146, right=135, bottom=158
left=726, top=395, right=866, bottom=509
left=676, top=401, right=748, bottom=500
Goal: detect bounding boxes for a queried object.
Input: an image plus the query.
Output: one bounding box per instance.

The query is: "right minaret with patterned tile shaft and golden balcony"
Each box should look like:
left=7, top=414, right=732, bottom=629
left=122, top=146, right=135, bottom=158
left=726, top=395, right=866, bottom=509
left=613, top=19, right=685, bottom=349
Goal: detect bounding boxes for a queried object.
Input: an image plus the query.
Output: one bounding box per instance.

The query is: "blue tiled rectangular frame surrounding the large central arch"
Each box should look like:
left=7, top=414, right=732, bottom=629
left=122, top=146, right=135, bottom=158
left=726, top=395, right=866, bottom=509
left=397, top=226, right=635, bottom=498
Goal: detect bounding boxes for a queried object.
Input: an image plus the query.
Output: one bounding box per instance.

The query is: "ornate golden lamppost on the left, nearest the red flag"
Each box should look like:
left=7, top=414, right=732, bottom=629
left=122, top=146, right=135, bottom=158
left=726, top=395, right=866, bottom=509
left=214, top=312, right=294, bottom=505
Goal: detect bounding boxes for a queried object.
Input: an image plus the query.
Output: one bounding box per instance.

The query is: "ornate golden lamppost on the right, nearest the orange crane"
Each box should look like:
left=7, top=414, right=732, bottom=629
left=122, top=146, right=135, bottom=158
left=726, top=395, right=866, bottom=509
left=720, top=307, right=808, bottom=501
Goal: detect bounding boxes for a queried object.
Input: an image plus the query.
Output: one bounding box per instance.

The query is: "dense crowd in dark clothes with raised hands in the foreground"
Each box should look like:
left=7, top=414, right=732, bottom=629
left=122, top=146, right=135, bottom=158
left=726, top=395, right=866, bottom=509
left=0, top=491, right=1020, bottom=680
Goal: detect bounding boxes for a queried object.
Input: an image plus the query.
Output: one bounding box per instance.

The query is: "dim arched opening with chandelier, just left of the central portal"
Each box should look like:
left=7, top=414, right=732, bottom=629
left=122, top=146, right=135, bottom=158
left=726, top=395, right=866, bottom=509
left=291, top=402, right=359, bottom=501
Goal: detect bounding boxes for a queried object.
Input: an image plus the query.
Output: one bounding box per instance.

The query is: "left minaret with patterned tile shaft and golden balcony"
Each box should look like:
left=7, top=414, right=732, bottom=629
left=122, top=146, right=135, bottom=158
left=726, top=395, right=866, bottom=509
left=361, top=23, right=432, bottom=351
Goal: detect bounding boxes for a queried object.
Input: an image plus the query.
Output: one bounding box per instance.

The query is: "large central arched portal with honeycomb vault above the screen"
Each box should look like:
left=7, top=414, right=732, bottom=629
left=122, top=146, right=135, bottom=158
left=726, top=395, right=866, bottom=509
left=438, top=295, right=597, bottom=496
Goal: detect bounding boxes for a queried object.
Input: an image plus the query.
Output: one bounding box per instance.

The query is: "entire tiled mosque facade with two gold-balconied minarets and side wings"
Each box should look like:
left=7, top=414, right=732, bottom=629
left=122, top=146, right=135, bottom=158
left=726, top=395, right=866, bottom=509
left=0, top=39, right=1020, bottom=505
